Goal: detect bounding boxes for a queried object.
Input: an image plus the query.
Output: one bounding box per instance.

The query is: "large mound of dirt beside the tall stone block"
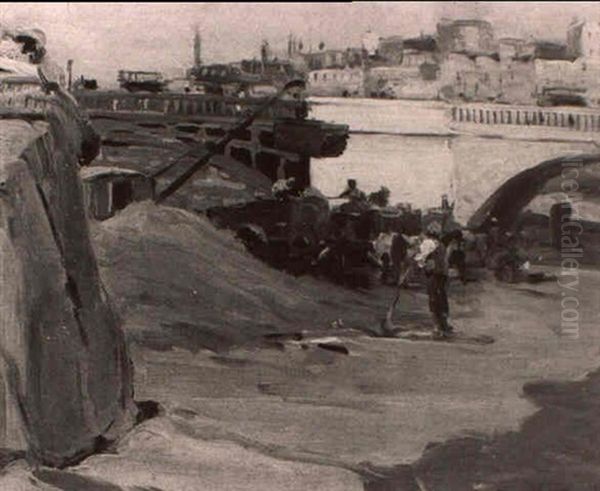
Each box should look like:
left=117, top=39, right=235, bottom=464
left=93, top=203, right=398, bottom=350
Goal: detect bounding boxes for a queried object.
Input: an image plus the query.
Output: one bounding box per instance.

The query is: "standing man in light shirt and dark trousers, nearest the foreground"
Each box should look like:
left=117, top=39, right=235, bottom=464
left=415, top=221, right=452, bottom=338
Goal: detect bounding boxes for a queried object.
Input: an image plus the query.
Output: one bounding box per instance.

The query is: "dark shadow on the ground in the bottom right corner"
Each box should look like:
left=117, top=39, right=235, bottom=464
left=404, top=371, right=600, bottom=491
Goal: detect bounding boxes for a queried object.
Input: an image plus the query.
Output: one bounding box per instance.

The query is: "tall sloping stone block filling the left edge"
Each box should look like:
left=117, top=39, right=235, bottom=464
left=0, top=96, right=134, bottom=466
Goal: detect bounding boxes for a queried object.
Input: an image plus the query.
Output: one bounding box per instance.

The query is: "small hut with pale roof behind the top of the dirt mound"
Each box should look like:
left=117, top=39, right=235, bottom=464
left=81, top=166, right=154, bottom=220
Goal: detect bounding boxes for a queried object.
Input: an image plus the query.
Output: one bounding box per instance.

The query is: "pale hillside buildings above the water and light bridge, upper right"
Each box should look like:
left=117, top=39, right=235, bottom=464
left=254, top=19, right=600, bottom=106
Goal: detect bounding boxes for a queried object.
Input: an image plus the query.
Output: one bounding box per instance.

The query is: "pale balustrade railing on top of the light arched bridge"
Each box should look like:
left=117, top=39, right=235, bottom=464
left=452, top=106, right=600, bottom=132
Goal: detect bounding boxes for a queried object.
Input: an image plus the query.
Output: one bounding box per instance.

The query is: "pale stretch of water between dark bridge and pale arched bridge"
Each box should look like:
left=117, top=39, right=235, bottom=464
left=311, top=98, right=453, bottom=208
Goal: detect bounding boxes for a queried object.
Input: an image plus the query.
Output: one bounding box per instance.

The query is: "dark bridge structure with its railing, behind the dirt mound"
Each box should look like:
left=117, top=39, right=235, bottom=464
left=74, top=91, right=348, bottom=199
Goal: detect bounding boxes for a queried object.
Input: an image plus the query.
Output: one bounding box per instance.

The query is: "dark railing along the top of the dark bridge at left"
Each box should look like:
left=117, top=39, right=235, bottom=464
left=74, top=92, right=299, bottom=119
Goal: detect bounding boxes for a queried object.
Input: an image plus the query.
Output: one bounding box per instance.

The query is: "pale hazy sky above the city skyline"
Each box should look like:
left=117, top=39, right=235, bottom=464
left=0, top=2, right=600, bottom=87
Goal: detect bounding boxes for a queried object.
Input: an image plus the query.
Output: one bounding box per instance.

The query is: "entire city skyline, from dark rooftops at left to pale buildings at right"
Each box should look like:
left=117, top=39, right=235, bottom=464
left=67, top=18, right=600, bottom=107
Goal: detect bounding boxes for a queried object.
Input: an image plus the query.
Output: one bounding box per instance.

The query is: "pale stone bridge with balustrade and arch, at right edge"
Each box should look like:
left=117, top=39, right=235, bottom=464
left=449, top=105, right=600, bottom=226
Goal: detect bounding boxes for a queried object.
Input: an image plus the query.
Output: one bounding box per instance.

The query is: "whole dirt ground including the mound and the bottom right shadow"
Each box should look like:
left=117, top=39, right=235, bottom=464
left=0, top=204, right=600, bottom=491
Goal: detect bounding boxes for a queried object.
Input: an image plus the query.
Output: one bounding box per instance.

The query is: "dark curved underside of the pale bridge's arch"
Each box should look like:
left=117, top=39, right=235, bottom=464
left=467, top=153, right=600, bottom=230
